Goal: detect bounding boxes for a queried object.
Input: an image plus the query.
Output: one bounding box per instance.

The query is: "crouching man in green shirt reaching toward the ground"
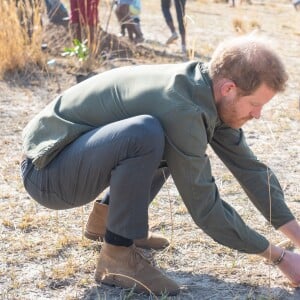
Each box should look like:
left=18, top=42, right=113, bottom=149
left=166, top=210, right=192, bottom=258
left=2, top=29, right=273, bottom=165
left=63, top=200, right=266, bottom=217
left=22, top=36, right=300, bottom=295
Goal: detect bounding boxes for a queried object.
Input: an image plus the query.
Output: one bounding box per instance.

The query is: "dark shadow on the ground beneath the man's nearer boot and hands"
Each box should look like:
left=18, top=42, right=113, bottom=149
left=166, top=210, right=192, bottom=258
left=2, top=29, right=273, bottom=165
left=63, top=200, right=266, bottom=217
left=81, top=272, right=300, bottom=300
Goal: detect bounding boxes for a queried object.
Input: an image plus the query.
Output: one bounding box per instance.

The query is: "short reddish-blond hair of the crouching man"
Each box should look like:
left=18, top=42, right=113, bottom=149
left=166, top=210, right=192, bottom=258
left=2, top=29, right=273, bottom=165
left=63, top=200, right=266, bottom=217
left=208, top=34, right=288, bottom=95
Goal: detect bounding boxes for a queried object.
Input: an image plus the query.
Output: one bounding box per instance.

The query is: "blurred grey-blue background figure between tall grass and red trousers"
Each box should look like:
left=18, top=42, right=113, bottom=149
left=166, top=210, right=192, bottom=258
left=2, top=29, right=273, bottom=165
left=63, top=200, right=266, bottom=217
left=45, top=0, right=69, bottom=28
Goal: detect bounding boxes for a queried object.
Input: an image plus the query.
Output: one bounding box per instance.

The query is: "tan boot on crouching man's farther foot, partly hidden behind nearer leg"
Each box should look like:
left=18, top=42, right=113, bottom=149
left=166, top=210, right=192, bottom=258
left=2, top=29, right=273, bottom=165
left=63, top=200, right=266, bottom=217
left=84, top=201, right=170, bottom=250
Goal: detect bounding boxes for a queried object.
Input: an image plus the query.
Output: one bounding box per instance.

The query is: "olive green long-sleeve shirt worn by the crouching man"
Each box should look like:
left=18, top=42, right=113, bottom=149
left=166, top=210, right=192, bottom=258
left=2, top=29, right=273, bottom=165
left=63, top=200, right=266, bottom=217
left=23, top=62, right=294, bottom=253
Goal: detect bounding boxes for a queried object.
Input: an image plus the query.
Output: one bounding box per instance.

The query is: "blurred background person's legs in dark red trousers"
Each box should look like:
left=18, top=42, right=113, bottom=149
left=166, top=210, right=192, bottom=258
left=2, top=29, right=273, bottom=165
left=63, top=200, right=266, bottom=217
left=70, top=0, right=99, bottom=52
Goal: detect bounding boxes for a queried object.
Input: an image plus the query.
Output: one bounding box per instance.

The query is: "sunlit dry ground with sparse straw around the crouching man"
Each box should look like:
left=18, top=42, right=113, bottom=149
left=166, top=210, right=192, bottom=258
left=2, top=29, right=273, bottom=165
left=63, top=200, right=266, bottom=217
left=0, top=0, right=300, bottom=300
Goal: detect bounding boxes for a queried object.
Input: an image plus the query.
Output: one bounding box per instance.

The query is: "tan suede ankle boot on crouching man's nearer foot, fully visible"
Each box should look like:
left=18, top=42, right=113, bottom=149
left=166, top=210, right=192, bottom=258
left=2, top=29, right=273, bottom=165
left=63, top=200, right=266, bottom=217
left=95, top=242, right=179, bottom=296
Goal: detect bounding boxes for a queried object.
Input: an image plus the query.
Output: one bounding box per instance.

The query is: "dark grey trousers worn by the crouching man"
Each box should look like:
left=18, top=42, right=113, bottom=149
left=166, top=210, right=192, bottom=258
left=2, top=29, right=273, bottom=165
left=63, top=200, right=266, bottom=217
left=21, top=115, right=169, bottom=239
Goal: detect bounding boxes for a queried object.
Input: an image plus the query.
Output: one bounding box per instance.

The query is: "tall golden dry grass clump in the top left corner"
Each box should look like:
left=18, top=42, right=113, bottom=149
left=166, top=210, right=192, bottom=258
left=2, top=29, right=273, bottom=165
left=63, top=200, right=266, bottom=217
left=0, top=0, right=44, bottom=78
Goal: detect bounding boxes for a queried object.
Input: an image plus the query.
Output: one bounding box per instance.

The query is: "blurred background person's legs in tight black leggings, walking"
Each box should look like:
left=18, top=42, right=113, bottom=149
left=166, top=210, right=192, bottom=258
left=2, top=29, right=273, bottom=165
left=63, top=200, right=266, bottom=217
left=161, top=0, right=186, bottom=54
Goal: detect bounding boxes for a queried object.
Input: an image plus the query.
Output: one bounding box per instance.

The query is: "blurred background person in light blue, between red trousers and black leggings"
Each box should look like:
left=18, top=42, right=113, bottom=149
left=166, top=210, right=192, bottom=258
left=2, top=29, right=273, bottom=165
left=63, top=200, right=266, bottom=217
left=115, top=0, right=144, bottom=43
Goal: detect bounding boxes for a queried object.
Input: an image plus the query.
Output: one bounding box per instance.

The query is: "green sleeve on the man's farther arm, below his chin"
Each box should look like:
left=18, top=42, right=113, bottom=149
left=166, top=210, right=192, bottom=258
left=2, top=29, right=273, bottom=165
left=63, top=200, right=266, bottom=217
left=210, top=125, right=294, bottom=229
